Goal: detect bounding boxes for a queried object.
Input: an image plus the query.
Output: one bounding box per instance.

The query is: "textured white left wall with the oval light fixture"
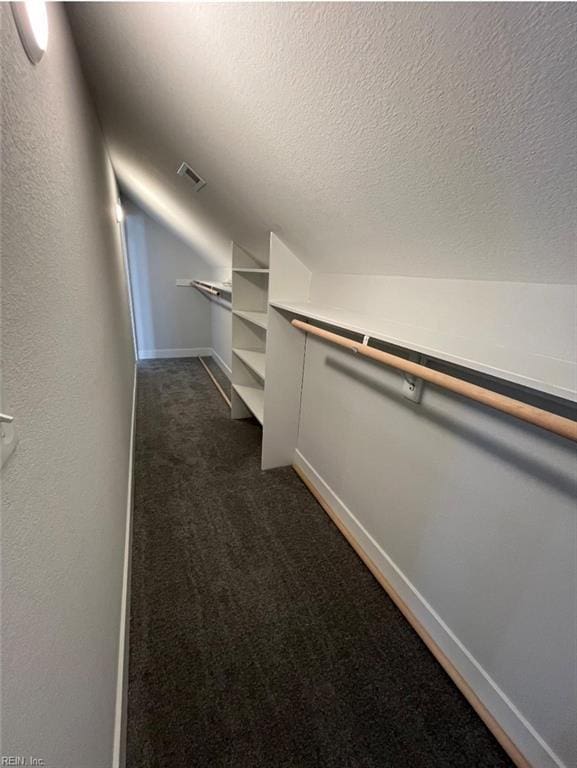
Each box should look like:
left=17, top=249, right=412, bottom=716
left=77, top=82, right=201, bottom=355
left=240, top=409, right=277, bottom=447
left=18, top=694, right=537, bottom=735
left=0, top=3, right=134, bottom=768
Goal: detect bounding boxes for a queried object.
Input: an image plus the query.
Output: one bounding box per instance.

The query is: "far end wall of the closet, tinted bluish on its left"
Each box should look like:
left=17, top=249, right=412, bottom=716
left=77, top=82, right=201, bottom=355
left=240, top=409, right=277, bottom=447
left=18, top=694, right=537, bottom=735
left=124, top=200, right=214, bottom=358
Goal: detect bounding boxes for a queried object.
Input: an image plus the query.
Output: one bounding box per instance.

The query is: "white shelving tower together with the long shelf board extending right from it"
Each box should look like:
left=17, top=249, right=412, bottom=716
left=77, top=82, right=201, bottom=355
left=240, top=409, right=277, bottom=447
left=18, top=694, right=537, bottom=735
left=226, top=234, right=577, bottom=469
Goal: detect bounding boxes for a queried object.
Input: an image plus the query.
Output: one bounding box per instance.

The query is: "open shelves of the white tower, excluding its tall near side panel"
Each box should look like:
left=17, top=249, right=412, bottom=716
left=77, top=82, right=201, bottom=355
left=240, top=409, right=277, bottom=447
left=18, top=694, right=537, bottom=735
left=231, top=244, right=269, bottom=425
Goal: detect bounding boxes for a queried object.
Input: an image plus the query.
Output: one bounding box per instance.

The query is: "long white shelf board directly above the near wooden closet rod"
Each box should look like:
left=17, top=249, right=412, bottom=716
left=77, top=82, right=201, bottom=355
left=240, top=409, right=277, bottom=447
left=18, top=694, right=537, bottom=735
left=271, top=301, right=577, bottom=401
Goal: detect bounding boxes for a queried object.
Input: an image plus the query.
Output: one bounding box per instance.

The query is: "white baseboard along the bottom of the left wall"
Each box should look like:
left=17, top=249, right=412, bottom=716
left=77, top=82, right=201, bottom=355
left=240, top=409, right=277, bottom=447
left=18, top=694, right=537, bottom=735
left=112, top=362, right=137, bottom=768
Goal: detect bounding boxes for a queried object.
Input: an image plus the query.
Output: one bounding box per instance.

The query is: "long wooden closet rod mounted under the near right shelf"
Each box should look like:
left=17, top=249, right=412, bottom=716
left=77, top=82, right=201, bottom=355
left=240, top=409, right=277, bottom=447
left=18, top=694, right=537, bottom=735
left=292, top=320, right=577, bottom=442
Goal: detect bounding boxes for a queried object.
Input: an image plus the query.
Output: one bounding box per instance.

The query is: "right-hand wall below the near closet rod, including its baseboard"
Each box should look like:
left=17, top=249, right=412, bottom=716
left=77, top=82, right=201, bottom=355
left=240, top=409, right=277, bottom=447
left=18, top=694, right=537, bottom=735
left=297, top=337, right=577, bottom=767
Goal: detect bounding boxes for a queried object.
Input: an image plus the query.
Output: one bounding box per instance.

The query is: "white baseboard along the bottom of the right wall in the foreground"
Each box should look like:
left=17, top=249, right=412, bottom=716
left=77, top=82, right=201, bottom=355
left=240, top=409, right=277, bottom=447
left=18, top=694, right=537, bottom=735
left=294, top=450, right=568, bottom=768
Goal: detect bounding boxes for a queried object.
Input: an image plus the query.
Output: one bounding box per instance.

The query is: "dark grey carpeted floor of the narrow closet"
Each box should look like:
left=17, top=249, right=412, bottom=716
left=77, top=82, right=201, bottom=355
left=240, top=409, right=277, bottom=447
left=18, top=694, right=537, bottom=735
left=127, top=360, right=511, bottom=768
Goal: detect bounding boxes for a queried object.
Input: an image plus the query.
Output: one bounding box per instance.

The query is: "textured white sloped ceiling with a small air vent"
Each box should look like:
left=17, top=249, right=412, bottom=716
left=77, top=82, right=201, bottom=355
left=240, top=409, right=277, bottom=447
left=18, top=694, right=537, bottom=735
left=68, top=2, right=577, bottom=282
